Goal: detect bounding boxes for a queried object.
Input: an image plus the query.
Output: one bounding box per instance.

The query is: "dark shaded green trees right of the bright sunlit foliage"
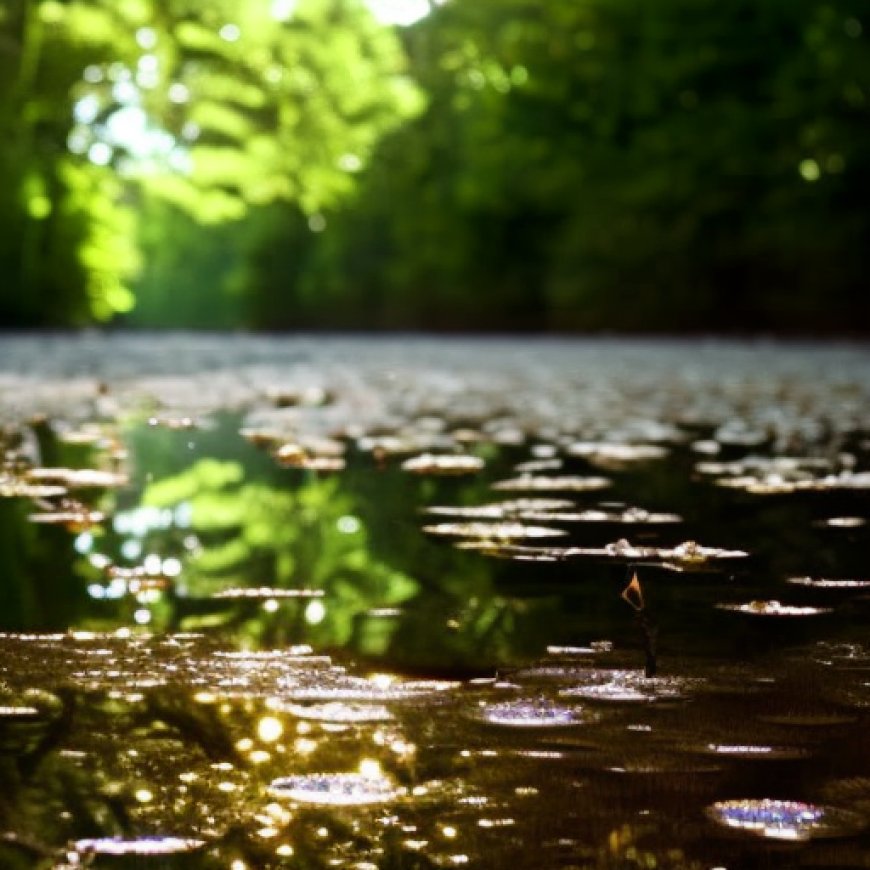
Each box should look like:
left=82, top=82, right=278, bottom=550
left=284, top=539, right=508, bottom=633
left=252, top=0, right=870, bottom=330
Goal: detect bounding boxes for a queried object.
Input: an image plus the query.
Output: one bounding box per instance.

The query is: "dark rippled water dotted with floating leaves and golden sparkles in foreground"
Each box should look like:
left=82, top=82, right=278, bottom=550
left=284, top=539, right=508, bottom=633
left=0, top=350, right=870, bottom=870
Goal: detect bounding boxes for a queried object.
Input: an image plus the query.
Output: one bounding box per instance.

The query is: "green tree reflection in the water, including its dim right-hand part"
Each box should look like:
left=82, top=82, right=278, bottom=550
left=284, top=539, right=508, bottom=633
left=142, top=459, right=543, bottom=671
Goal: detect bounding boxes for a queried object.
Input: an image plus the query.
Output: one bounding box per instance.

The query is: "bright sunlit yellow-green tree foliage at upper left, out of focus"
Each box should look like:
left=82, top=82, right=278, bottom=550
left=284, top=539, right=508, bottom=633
left=0, top=0, right=420, bottom=325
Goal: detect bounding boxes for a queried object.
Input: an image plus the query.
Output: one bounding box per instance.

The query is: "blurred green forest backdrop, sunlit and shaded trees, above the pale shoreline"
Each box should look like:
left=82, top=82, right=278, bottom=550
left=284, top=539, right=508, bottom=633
left=0, top=0, right=870, bottom=334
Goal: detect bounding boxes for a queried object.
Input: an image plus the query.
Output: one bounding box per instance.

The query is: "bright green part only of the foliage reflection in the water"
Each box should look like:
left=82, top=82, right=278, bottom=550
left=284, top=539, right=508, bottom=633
left=143, top=459, right=417, bottom=644
